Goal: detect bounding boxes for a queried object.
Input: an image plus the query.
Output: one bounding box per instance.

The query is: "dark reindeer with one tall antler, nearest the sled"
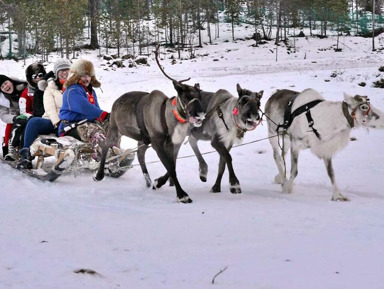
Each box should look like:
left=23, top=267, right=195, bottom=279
left=94, top=46, right=205, bottom=203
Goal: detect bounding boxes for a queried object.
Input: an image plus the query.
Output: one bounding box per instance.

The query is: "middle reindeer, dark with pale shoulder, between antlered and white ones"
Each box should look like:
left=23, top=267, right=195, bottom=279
left=189, top=84, right=264, bottom=194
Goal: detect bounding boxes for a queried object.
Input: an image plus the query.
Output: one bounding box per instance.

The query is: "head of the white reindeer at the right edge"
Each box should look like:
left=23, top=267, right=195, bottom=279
left=344, top=93, right=384, bottom=129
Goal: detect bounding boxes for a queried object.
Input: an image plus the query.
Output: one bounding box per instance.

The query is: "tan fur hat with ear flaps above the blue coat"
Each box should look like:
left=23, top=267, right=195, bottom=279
left=64, top=59, right=101, bottom=88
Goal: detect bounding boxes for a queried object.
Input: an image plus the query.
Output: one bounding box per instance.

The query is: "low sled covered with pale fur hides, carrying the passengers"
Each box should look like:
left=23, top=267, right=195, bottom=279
left=2, top=135, right=135, bottom=182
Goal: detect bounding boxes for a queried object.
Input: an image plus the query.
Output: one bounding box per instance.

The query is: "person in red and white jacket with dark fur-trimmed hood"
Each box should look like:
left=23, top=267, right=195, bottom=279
left=7, top=63, right=46, bottom=161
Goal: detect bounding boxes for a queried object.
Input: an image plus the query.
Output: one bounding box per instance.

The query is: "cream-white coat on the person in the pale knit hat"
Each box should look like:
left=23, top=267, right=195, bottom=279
left=43, top=80, right=63, bottom=126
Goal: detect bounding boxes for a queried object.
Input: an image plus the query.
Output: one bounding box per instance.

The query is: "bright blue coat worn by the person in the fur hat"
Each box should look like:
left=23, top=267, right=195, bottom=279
left=59, top=84, right=108, bottom=132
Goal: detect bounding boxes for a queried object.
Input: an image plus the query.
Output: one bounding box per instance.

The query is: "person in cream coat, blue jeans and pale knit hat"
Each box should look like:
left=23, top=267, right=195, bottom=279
left=17, top=58, right=71, bottom=169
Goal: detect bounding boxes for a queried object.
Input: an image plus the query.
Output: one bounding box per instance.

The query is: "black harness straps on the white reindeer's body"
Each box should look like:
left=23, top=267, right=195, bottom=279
left=276, top=93, right=324, bottom=139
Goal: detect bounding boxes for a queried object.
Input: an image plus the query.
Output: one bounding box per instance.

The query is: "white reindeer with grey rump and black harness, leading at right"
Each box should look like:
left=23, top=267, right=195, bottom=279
left=265, top=89, right=384, bottom=201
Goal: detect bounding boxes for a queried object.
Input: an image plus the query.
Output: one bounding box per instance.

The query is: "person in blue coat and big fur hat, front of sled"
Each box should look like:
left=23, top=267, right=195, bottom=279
left=58, top=59, right=109, bottom=161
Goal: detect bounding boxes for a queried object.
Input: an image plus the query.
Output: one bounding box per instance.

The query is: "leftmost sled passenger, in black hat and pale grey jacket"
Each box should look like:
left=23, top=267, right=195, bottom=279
left=0, top=74, right=27, bottom=160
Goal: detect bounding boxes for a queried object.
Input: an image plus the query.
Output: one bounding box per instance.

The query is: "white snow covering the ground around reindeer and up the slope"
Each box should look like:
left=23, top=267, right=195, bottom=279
left=0, top=27, right=384, bottom=289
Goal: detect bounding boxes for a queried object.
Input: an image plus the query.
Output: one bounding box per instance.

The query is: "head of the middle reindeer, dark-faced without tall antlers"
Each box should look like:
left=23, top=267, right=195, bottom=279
left=234, top=84, right=264, bottom=130
